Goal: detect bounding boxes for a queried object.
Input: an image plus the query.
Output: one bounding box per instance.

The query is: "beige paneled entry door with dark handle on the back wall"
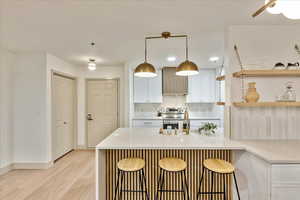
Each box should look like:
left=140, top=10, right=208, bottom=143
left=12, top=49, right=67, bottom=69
left=87, top=80, right=119, bottom=147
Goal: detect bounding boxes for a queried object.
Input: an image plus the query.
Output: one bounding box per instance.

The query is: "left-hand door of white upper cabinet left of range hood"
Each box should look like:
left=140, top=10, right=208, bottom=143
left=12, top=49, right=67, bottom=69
left=133, top=77, right=149, bottom=103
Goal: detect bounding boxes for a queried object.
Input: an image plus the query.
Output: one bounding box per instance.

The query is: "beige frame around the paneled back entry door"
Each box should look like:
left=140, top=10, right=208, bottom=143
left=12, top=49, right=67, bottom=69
left=84, top=78, right=121, bottom=149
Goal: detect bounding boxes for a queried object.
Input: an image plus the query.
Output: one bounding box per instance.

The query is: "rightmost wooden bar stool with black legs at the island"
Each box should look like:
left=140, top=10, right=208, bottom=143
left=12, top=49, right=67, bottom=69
left=197, top=159, right=240, bottom=200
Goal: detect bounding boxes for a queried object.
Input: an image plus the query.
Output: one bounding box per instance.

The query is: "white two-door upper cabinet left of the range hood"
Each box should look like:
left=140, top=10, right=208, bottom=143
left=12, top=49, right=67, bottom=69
left=133, top=70, right=162, bottom=103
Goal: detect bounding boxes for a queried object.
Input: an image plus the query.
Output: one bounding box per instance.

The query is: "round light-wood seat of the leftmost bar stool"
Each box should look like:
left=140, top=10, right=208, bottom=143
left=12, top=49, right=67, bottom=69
left=117, top=158, right=145, bottom=172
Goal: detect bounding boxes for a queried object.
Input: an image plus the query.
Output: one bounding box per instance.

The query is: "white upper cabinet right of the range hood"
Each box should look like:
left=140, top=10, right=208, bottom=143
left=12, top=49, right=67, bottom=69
left=187, top=69, right=216, bottom=103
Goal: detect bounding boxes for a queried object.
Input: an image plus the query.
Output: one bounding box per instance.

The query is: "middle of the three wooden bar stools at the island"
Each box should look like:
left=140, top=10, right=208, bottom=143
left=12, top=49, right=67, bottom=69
left=155, top=158, right=190, bottom=200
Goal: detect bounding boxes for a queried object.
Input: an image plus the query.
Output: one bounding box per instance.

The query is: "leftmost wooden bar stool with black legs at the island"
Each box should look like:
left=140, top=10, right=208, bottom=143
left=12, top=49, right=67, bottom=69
left=114, top=158, right=149, bottom=200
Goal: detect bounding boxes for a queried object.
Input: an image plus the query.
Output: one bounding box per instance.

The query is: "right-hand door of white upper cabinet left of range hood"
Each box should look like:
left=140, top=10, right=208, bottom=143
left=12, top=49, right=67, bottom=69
left=148, top=70, right=162, bottom=103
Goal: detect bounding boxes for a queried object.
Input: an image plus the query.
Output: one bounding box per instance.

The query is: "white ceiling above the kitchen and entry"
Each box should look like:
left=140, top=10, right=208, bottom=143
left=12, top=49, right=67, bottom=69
left=0, top=0, right=299, bottom=66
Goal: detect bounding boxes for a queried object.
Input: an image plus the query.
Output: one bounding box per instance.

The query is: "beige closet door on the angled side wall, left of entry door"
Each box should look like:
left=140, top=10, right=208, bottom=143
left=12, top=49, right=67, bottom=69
left=52, top=75, right=75, bottom=160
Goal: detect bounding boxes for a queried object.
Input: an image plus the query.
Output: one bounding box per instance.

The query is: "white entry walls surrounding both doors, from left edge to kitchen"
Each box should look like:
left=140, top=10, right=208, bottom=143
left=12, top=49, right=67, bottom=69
left=0, top=49, right=127, bottom=169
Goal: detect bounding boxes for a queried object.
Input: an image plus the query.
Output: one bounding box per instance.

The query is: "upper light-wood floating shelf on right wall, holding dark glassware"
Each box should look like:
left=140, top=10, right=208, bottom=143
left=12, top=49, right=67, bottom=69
left=233, top=69, right=300, bottom=78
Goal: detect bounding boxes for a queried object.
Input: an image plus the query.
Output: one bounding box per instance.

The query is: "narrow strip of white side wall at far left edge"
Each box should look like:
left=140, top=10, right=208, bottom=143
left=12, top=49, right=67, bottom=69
left=0, top=47, right=15, bottom=174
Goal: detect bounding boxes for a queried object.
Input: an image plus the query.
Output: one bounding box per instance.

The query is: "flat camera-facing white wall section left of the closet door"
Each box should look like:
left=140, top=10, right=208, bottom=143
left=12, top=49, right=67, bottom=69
left=13, top=53, right=49, bottom=163
